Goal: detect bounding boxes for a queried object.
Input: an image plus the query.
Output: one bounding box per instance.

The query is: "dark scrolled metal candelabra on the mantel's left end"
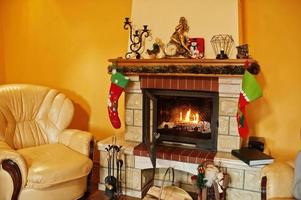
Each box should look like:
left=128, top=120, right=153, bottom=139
left=123, top=17, right=150, bottom=59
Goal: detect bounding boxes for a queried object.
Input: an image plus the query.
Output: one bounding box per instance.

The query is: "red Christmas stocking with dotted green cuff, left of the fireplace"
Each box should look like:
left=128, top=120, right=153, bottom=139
left=108, top=69, right=129, bottom=129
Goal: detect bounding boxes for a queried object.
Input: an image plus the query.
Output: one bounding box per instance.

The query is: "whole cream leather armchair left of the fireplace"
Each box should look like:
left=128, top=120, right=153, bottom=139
left=0, top=84, right=92, bottom=200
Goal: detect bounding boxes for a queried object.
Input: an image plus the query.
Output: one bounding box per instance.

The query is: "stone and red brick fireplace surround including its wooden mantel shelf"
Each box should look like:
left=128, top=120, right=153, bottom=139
left=98, top=59, right=260, bottom=199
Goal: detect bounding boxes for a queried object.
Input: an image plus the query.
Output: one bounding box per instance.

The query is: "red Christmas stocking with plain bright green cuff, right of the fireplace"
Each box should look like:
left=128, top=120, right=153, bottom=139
left=236, top=64, right=262, bottom=138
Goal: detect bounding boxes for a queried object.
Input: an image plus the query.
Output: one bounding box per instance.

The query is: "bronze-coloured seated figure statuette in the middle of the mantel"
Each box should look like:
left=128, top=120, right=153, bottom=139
left=165, top=17, right=191, bottom=58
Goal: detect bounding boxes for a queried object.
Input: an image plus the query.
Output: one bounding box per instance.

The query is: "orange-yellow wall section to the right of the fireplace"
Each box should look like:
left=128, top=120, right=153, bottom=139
left=242, top=0, right=301, bottom=159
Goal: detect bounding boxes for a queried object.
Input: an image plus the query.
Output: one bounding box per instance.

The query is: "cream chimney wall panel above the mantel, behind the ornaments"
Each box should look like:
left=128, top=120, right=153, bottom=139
left=131, top=0, right=239, bottom=58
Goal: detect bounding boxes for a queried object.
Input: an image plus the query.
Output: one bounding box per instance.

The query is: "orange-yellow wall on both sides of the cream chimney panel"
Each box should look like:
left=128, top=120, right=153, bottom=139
left=0, top=0, right=301, bottom=159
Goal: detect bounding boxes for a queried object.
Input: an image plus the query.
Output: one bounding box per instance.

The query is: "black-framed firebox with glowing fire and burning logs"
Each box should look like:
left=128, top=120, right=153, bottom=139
left=143, top=89, right=218, bottom=150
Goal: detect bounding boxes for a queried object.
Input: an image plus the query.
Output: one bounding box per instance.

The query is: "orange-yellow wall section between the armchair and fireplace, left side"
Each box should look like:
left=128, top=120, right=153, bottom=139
left=0, top=0, right=131, bottom=139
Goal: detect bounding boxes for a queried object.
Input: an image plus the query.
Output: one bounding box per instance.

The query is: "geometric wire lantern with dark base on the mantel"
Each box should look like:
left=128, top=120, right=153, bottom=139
left=210, top=34, right=234, bottom=59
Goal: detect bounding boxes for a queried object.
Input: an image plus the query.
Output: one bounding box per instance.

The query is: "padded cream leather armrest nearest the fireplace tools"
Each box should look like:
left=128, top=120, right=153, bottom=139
left=58, top=129, right=92, bottom=156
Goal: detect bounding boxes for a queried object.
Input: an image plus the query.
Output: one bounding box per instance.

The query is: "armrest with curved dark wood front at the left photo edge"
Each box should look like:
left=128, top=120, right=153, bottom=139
left=0, top=141, right=27, bottom=200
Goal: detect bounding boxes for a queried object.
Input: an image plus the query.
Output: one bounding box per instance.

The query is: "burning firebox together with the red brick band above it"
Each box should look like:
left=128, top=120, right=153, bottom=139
left=140, top=76, right=218, bottom=151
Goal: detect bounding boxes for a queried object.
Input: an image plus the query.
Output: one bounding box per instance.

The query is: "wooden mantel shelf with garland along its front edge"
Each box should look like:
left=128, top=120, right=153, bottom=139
left=108, top=58, right=259, bottom=77
